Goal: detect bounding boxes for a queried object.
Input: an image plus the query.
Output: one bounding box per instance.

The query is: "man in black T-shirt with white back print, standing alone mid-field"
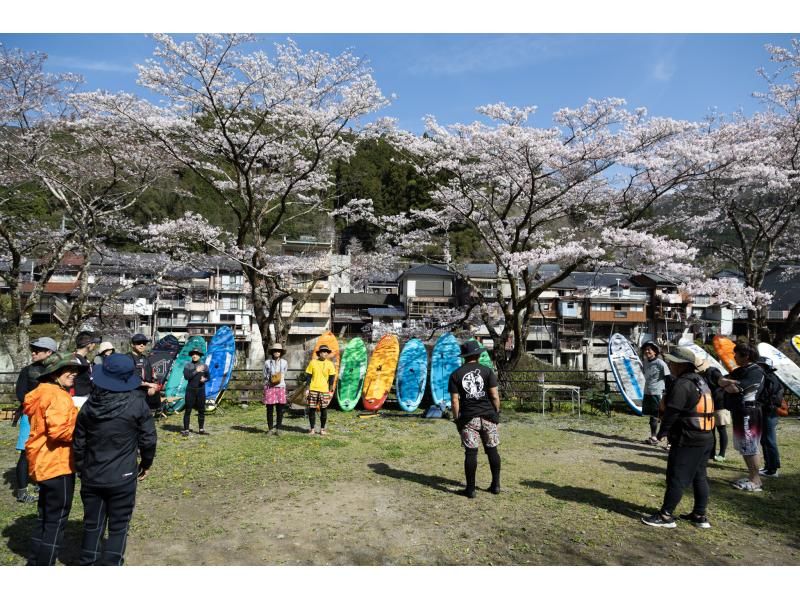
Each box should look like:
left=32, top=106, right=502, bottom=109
left=447, top=340, right=500, bottom=498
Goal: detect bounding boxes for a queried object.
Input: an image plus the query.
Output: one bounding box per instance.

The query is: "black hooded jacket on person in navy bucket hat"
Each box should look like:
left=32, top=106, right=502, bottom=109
left=73, top=388, right=156, bottom=487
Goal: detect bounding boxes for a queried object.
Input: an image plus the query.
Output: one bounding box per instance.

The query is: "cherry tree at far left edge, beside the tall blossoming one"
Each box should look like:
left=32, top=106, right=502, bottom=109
left=0, top=46, right=164, bottom=366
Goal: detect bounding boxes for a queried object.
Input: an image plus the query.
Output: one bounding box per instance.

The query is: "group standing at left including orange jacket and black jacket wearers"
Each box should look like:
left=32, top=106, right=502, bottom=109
left=16, top=333, right=156, bottom=565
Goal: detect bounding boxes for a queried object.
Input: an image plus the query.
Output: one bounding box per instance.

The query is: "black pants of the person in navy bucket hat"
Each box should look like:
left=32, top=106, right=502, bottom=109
left=80, top=478, right=136, bottom=565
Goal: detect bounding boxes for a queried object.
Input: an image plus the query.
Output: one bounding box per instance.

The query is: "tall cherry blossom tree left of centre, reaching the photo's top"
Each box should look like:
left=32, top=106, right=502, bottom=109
left=86, top=35, right=386, bottom=351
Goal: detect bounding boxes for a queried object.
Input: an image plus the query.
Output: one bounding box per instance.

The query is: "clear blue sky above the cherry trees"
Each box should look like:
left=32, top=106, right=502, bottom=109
left=0, top=33, right=798, bottom=133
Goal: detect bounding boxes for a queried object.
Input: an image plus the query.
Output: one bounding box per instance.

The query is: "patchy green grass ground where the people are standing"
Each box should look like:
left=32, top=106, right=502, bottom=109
left=0, top=404, right=800, bottom=565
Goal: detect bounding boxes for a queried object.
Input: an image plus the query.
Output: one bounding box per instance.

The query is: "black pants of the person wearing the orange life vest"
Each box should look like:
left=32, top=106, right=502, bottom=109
left=661, top=439, right=714, bottom=515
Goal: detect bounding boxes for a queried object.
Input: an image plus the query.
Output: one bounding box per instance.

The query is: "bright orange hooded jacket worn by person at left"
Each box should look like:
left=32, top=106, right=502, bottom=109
left=22, top=382, right=78, bottom=482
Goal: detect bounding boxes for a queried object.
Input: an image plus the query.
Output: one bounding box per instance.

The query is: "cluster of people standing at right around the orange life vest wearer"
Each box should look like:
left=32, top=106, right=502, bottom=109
left=642, top=343, right=783, bottom=528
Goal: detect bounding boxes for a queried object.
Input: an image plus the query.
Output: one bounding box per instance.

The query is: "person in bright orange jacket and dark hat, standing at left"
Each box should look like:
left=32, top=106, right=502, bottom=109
left=22, top=353, right=87, bottom=565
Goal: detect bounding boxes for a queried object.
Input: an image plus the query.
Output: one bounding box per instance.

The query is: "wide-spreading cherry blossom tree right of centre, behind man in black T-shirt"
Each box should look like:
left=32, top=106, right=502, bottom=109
left=337, top=99, right=700, bottom=376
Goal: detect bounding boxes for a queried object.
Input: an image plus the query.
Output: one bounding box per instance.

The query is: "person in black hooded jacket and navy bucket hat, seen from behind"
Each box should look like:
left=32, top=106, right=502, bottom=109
left=73, top=353, right=156, bottom=565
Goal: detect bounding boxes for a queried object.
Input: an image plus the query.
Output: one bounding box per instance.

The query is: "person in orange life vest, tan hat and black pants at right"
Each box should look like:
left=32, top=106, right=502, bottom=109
left=642, top=347, right=714, bottom=528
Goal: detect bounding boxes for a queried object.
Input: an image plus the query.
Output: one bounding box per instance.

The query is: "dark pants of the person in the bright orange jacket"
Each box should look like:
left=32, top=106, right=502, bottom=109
left=28, top=473, right=75, bottom=565
